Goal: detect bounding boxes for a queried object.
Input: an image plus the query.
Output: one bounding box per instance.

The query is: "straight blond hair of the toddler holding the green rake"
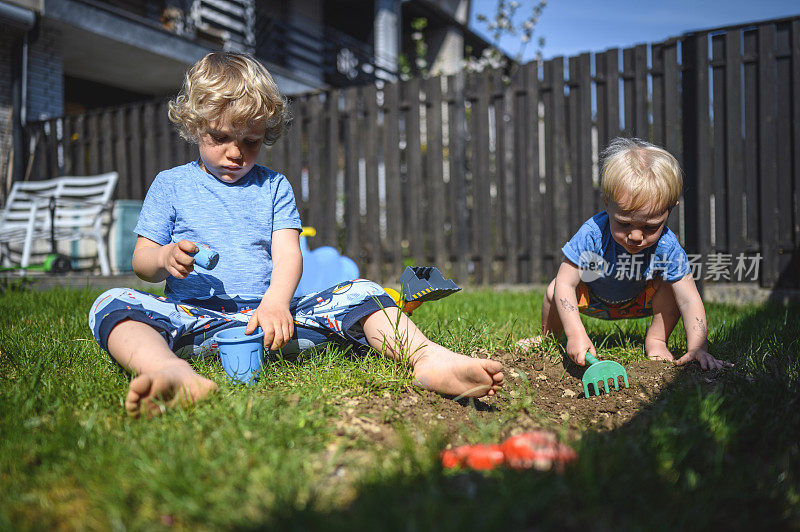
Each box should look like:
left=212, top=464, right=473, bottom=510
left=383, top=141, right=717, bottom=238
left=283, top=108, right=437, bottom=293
left=600, top=138, right=683, bottom=214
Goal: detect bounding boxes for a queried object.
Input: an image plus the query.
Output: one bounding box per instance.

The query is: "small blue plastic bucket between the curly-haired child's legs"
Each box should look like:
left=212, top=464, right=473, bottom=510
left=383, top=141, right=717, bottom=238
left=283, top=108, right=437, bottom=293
left=214, top=327, right=264, bottom=384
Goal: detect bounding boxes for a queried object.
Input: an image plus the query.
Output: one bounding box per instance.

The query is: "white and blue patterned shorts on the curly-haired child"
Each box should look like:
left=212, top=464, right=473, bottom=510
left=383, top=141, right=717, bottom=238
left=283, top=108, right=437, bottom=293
left=89, top=279, right=397, bottom=358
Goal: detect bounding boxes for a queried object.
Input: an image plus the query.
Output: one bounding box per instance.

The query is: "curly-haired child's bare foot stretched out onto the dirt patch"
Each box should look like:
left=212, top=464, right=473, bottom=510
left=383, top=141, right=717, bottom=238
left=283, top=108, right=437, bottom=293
left=411, top=344, right=503, bottom=397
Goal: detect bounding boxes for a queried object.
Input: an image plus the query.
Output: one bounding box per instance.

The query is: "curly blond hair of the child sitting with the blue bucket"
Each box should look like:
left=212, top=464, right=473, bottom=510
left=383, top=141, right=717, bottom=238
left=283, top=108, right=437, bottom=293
left=168, top=52, right=288, bottom=146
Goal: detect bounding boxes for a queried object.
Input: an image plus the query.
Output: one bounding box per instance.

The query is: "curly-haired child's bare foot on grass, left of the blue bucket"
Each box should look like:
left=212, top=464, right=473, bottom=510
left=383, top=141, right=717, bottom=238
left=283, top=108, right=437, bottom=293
left=125, top=360, right=217, bottom=417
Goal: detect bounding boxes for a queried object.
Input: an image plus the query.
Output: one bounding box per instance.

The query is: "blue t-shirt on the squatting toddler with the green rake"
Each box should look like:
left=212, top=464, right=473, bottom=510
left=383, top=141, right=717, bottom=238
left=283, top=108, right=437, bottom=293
left=561, top=211, right=690, bottom=303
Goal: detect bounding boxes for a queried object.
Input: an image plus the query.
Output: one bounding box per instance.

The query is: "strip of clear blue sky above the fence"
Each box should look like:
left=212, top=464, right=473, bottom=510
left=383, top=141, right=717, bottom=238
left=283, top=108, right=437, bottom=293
left=471, top=0, right=800, bottom=60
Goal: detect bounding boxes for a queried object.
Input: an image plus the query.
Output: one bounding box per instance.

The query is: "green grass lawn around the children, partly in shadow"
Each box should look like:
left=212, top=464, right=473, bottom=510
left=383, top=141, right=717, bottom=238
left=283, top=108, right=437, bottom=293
left=0, top=289, right=800, bottom=530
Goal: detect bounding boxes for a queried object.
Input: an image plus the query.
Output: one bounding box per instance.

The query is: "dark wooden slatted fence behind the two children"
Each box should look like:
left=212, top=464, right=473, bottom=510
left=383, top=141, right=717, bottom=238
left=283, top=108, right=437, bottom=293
left=21, top=17, right=800, bottom=287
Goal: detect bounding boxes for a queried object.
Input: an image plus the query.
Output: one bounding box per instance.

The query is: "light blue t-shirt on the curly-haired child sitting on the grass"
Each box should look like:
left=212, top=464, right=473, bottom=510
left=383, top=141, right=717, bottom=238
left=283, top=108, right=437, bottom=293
left=134, top=161, right=302, bottom=300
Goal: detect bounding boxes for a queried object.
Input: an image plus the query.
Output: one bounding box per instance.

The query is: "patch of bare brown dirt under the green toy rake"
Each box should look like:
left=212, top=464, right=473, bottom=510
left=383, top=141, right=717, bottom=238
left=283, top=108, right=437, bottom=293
left=324, top=353, right=723, bottom=445
